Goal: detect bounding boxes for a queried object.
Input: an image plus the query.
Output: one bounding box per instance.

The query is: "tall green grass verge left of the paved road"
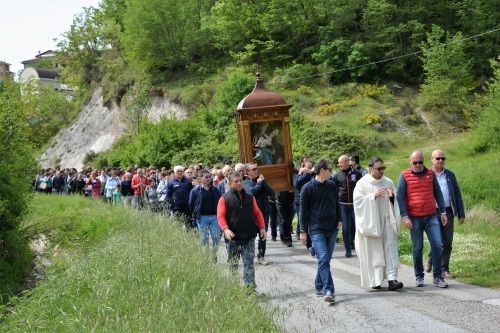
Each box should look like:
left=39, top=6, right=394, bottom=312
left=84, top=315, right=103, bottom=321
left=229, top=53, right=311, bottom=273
left=0, top=197, right=278, bottom=332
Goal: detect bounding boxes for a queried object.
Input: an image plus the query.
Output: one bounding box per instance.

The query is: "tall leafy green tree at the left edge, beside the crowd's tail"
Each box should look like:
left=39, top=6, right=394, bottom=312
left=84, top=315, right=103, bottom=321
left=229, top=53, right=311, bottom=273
left=0, top=78, right=69, bottom=303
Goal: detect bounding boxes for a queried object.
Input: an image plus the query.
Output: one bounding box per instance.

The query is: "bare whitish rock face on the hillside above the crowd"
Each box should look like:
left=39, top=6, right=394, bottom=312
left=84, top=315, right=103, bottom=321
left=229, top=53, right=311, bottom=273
left=39, top=88, right=187, bottom=171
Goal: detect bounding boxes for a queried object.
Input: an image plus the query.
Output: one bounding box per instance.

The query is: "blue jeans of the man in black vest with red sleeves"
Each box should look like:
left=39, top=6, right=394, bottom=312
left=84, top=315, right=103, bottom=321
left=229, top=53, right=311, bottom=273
left=226, top=238, right=255, bottom=287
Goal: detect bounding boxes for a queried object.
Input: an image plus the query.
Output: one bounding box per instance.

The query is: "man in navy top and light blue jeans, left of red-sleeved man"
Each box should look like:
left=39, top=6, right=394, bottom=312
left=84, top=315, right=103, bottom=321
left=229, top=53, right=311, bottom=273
left=189, top=169, right=220, bottom=253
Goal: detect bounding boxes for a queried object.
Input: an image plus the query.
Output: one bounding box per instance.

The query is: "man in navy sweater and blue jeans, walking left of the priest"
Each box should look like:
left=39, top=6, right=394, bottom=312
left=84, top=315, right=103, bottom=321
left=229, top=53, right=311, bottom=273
left=299, top=158, right=342, bottom=303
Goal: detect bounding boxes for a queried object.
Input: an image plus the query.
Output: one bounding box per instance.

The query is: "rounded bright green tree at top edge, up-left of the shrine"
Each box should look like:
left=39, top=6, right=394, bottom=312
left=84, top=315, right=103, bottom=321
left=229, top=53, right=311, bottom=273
left=124, top=0, right=209, bottom=75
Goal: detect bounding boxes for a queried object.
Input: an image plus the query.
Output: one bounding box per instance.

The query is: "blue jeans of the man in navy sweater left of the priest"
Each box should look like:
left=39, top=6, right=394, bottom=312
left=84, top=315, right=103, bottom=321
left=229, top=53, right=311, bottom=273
left=311, top=229, right=339, bottom=293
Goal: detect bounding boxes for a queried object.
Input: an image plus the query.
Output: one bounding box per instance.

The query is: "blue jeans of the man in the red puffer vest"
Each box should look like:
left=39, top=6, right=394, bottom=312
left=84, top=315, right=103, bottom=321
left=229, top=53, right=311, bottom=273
left=409, top=214, right=442, bottom=279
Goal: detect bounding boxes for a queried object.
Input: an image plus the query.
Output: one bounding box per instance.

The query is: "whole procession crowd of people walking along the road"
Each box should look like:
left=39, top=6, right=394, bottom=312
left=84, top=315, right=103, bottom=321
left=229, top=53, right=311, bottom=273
left=33, top=150, right=465, bottom=303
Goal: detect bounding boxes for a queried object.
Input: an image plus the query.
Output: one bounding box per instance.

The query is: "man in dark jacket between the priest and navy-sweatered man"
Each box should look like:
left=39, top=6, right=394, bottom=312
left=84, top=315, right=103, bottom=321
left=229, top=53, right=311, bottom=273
left=333, top=155, right=362, bottom=258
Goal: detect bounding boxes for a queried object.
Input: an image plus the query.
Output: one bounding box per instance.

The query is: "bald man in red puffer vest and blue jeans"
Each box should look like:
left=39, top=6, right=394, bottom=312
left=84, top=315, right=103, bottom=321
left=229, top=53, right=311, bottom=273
left=397, top=150, right=448, bottom=288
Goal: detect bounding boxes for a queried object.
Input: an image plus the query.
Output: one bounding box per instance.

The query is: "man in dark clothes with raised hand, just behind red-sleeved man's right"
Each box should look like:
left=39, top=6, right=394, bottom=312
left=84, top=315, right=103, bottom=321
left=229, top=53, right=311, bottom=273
left=243, top=163, right=274, bottom=266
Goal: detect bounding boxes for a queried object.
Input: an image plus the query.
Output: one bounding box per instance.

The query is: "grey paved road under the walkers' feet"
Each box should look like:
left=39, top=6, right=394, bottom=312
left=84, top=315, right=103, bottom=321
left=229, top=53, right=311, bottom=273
left=250, top=240, right=500, bottom=333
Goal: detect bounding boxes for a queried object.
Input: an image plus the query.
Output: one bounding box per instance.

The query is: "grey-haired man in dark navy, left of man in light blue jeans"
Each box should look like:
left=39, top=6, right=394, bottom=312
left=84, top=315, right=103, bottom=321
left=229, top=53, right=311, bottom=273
left=165, top=165, right=196, bottom=228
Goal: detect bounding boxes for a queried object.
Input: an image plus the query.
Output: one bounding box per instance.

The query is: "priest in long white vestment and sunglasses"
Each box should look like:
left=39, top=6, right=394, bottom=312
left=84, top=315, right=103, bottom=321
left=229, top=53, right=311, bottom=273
left=354, top=157, right=403, bottom=290
